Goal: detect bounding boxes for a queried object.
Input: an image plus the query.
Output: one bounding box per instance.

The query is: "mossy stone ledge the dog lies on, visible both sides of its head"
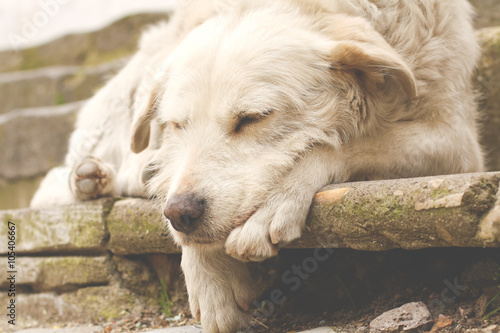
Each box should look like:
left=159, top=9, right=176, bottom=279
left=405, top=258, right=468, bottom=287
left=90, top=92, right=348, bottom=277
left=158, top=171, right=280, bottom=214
left=0, top=172, right=500, bottom=255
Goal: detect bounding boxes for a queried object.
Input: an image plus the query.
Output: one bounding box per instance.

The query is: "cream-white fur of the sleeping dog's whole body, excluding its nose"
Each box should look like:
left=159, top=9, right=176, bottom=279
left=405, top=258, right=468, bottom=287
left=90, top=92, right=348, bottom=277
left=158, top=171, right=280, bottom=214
left=32, top=0, right=483, bottom=332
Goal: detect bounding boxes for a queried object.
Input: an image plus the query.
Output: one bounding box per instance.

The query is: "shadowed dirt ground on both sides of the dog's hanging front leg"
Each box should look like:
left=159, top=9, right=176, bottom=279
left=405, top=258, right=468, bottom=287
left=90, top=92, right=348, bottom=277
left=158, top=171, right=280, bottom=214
left=94, top=248, right=500, bottom=333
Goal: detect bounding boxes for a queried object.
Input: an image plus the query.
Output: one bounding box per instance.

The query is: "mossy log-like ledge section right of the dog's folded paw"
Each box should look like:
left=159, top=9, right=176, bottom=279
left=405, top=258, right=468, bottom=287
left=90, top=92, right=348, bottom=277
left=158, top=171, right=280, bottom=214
left=287, top=172, right=500, bottom=251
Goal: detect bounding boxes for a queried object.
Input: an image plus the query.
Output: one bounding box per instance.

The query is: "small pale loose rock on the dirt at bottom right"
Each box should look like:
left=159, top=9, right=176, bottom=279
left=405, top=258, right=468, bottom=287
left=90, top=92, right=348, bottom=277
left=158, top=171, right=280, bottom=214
left=370, top=302, right=432, bottom=333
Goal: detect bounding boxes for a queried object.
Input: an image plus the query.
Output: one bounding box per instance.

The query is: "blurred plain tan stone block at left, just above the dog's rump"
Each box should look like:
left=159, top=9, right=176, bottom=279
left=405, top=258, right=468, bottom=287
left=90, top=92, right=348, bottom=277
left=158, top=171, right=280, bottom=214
left=0, top=102, right=84, bottom=180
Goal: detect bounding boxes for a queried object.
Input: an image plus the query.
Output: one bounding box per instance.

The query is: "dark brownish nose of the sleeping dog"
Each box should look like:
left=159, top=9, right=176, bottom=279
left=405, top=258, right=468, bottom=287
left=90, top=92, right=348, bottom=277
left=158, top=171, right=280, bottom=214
left=163, top=192, right=205, bottom=234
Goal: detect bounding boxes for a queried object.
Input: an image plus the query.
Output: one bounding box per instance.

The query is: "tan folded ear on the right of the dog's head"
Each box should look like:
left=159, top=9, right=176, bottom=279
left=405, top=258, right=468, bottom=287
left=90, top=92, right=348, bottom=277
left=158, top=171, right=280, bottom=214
left=330, top=41, right=418, bottom=99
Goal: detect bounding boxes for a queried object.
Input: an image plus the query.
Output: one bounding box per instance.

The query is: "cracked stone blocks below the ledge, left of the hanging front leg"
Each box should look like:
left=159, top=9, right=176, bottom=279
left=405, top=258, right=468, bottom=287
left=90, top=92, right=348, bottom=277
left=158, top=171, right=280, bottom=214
left=0, top=254, right=183, bottom=332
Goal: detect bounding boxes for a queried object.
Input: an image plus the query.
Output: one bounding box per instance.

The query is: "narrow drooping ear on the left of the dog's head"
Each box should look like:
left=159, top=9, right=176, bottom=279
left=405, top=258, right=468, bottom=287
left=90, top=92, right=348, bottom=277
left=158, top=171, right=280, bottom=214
left=130, top=86, right=159, bottom=154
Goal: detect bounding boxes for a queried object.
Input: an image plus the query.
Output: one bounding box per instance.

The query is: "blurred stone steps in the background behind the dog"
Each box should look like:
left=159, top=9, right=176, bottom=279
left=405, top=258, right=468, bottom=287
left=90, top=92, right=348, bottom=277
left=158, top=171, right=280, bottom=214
left=0, top=0, right=500, bottom=209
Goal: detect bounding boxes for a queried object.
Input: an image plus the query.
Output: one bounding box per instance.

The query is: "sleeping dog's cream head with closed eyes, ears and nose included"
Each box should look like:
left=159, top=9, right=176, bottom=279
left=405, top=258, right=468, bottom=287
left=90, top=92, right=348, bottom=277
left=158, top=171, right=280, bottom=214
left=132, top=6, right=416, bottom=245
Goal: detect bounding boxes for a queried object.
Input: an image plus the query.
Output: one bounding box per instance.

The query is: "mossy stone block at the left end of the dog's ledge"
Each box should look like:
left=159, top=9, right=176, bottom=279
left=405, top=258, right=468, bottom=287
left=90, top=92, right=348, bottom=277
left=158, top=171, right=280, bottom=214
left=0, top=198, right=113, bottom=255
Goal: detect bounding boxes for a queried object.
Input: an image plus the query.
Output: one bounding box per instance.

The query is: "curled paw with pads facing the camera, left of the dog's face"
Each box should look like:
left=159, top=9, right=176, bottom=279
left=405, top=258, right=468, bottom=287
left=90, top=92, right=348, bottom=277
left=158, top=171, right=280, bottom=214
left=70, top=156, right=114, bottom=200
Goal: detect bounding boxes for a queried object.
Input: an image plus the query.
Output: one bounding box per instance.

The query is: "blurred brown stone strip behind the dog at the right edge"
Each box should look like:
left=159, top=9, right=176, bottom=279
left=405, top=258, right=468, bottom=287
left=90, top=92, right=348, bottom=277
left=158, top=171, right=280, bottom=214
left=474, top=26, right=500, bottom=170
